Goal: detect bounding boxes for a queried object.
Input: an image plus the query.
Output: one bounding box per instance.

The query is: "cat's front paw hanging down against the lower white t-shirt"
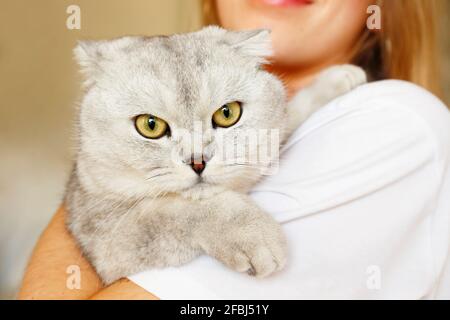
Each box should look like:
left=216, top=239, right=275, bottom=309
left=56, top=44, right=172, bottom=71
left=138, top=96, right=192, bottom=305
left=208, top=221, right=287, bottom=277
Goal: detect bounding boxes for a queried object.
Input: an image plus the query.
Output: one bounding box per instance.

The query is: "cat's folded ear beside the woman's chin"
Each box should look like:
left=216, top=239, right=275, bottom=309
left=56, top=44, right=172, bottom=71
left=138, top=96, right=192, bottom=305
left=231, top=29, right=273, bottom=64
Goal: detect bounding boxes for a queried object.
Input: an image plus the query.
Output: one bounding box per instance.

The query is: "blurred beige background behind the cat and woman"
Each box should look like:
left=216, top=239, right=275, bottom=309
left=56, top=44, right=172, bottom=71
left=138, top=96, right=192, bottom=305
left=0, top=0, right=450, bottom=299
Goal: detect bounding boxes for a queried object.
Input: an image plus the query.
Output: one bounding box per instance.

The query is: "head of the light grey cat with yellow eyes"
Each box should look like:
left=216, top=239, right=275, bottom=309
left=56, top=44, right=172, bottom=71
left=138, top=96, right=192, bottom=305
left=75, top=28, right=286, bottom=197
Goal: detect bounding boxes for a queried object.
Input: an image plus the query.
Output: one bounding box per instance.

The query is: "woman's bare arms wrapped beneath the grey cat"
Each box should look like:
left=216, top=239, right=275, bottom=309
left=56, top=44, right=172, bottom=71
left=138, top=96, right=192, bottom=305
left=18, top=207, right=157, bottom=299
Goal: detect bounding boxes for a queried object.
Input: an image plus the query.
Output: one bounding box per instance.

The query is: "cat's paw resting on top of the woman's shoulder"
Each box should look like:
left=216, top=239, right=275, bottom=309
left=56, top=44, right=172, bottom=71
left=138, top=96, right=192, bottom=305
left=316, top=64, right=367, bottom=96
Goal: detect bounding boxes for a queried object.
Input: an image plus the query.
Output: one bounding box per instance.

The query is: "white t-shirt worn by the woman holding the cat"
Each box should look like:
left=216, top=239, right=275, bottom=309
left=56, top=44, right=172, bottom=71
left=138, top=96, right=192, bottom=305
left=130, top=80, right=450, bottom=299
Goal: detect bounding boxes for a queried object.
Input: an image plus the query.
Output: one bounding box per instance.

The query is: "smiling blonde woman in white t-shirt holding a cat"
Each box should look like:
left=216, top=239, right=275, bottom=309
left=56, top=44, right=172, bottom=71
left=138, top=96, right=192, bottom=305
left=20, top=0, right=450, bottom=299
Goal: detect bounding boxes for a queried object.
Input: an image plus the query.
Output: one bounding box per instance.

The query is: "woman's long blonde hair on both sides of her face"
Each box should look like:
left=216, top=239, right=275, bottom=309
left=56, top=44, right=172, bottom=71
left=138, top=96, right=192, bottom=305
left=202, top=0, right=443, bottom=97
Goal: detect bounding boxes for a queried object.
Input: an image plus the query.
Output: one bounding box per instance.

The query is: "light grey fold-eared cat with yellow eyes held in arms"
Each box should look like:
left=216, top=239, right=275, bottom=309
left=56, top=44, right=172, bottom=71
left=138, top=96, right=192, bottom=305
left=64, top=27, right=366, bottom=284
